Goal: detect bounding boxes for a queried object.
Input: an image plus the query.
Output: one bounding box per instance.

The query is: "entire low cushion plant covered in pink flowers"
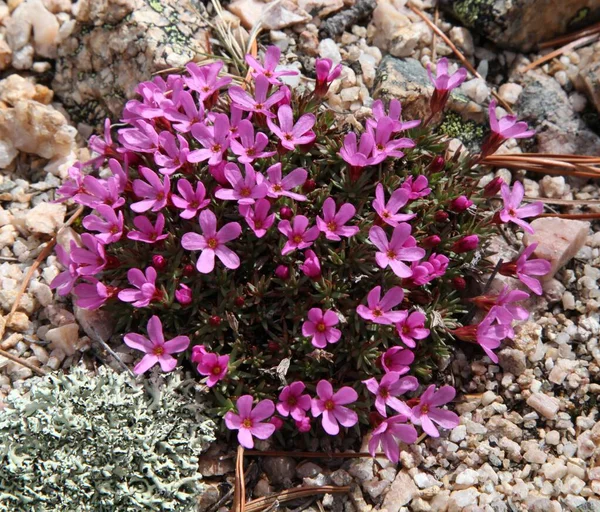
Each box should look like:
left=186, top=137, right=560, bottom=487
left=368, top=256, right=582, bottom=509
left=53, top=47, right=549, bottom=461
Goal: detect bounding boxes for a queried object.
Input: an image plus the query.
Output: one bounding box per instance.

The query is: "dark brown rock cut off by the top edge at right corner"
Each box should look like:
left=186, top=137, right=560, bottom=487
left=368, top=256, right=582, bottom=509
left=440, top=0, right=600, bottom=51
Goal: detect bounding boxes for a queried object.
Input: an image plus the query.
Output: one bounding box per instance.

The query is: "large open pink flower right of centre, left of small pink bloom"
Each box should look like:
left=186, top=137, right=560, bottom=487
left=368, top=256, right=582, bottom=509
left=369, top=222, right=425, bottom=277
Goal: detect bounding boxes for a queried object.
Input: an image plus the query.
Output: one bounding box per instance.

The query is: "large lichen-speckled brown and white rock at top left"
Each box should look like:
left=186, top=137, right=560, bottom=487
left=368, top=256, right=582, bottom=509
left=52, top=0, right=208, bottom=124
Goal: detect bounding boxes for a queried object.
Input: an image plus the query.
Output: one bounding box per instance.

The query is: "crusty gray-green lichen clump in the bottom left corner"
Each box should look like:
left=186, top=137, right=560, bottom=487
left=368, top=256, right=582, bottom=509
left=0, top=367, right=214, bottom=512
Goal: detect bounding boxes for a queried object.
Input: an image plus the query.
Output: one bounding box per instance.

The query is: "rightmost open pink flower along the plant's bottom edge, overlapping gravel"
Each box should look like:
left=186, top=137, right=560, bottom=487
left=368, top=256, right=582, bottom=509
left=410, top=384, right=460, bottom=437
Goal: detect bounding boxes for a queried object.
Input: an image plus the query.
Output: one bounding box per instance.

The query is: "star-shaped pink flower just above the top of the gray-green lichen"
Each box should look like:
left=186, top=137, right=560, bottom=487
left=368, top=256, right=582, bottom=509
left=124, top=315, right=190, bottom=375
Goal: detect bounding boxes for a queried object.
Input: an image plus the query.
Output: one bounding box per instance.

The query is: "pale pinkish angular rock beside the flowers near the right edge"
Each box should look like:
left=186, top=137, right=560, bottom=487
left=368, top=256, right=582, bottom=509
left=523, top=217, right=590, bottom=282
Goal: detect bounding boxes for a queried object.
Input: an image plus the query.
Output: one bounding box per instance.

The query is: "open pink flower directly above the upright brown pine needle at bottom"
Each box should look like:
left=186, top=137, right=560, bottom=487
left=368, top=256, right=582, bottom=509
left=225, top=395, right=275, bottom=450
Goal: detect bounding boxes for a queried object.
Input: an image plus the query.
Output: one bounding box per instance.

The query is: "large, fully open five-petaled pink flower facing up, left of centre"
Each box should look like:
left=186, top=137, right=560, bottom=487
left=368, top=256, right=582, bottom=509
left=181, top=210, right=242, bottom=274
